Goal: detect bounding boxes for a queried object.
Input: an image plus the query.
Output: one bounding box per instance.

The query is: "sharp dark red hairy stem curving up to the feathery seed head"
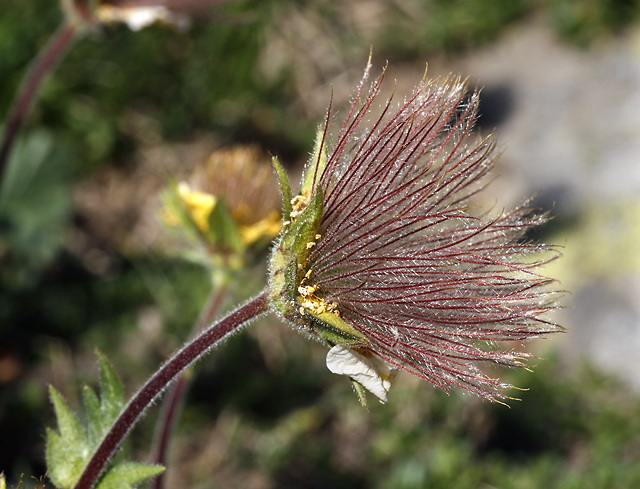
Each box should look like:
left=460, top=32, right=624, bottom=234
left=74, top=291, right=267, bottom=489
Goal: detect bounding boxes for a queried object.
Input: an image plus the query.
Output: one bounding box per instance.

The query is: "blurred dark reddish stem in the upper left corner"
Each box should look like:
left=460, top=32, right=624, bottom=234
left=0, top=21, right=82, bottom=184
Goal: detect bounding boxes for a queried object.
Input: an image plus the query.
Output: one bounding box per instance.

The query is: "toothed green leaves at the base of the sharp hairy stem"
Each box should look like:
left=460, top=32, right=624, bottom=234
left=47, top=350, right=163, bottom=489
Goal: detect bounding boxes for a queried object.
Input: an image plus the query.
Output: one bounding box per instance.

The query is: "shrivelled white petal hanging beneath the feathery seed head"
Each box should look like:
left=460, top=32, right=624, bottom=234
left=327, top=345, right=395, bottom=403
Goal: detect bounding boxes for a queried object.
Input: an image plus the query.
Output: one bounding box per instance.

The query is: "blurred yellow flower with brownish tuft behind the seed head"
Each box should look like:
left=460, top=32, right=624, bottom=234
left=160, top=146, right=281, bottom=268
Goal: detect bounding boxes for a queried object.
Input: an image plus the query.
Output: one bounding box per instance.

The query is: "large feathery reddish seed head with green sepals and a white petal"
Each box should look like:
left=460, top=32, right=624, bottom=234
left=270, top=64, right=562, bottom=403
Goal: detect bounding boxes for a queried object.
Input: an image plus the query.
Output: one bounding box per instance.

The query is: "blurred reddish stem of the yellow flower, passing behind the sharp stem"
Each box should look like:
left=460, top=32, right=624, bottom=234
left=153, top=284, right=227, bottom=489
